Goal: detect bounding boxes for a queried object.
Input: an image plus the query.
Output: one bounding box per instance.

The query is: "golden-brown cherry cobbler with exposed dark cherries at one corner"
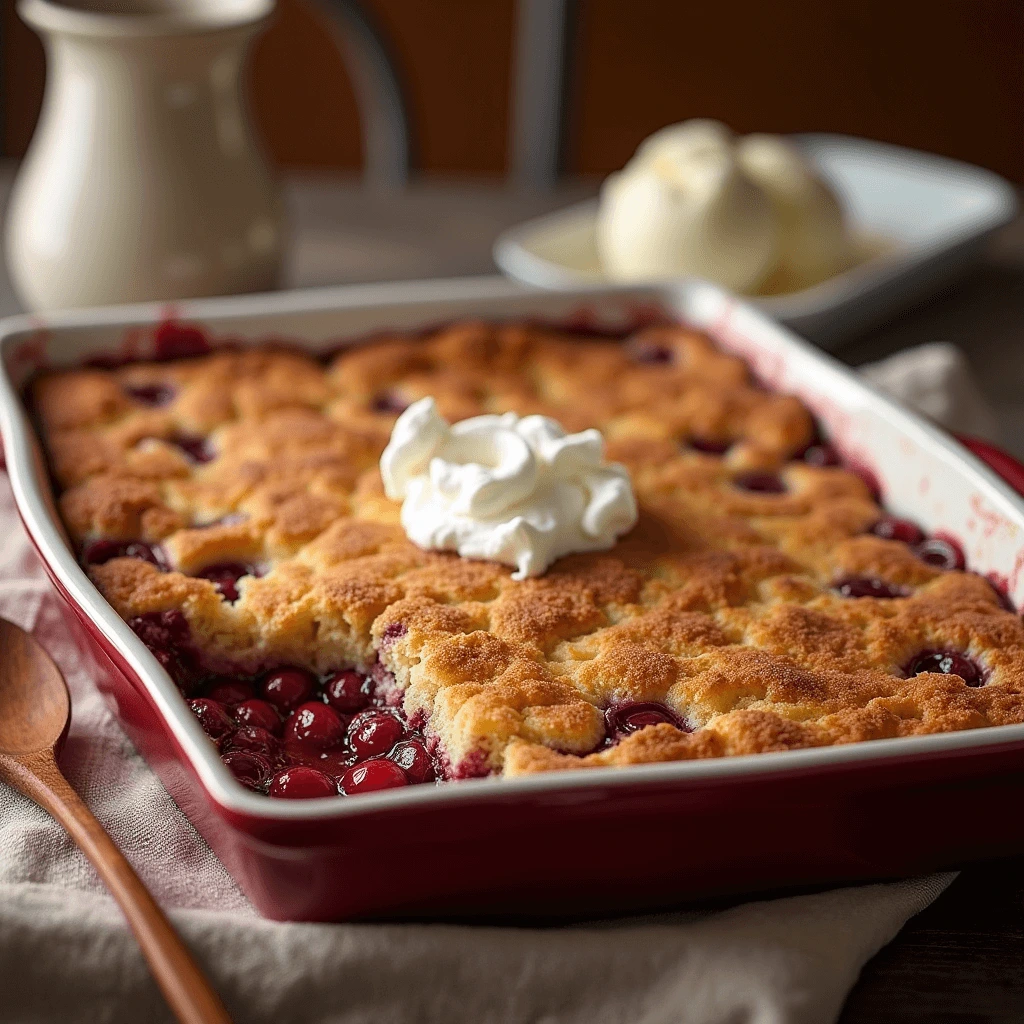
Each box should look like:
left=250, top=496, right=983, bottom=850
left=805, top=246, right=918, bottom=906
left=33, top=323, right=1024, bottom=798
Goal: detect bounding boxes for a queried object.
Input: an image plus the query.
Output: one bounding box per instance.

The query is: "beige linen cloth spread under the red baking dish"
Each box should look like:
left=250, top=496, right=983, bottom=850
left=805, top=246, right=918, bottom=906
left=0, top=346, right=991, bottom=1024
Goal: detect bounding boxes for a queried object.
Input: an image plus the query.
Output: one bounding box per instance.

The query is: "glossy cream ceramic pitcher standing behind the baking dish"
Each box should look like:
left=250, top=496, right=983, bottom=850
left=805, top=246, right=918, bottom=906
left=6, top=0, right=283, bottom=310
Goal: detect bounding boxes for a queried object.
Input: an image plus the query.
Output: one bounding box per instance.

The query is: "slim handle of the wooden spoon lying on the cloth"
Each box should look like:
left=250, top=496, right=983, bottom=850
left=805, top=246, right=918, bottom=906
left=0, top=751, right=231, bottom=1024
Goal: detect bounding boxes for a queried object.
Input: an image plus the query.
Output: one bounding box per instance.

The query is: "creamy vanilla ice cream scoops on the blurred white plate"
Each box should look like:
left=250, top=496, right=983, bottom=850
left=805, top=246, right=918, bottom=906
left=597, top=120, right=850, bottom=293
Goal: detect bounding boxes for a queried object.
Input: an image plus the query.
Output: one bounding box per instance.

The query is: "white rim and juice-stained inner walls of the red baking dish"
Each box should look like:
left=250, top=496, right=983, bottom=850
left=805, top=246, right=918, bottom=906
left=0, top=279, right=1024, bottom=820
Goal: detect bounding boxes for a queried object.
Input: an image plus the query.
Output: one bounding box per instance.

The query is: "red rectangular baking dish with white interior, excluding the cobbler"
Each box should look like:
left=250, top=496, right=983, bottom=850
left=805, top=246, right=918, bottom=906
left=0, top=279, right=1024, bottom=921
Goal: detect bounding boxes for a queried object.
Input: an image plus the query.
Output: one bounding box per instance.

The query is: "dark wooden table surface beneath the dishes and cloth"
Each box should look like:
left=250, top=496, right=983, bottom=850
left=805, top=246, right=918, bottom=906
left=0, top=165, right=1024, bottom=1024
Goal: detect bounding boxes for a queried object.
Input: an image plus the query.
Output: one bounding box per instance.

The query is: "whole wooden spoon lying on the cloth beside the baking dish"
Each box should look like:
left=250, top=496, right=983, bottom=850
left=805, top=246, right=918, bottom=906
left=0, top=618, right=230, bottom=1024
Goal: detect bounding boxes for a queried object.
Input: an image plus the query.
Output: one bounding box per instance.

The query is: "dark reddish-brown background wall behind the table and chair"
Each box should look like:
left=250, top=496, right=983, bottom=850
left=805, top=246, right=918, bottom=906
left=2, top=0, right=1024, bottom=181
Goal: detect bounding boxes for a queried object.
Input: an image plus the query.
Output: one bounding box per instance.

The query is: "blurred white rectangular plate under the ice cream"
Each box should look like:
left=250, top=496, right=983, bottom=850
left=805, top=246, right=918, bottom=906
left=494, top=134, right=1018, bottom=348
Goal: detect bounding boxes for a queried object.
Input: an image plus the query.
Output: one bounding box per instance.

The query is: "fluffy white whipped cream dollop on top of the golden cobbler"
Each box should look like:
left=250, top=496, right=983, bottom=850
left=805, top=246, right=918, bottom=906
left=380, top=398, right=637, bottom=580
